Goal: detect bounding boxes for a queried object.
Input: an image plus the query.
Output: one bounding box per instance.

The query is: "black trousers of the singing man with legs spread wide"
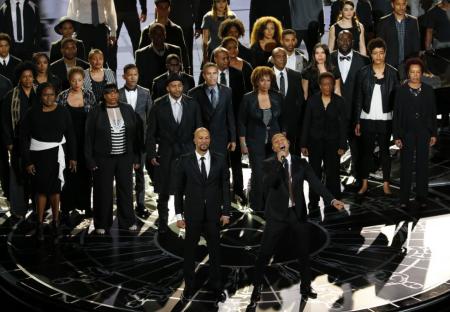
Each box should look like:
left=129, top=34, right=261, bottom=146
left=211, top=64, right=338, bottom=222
left=253, top=207, right=311, bottom=290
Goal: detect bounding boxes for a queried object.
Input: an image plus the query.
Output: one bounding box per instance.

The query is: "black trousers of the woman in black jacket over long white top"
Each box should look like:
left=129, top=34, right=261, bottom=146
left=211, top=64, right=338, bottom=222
left=361, top=120, right=392, bottom=182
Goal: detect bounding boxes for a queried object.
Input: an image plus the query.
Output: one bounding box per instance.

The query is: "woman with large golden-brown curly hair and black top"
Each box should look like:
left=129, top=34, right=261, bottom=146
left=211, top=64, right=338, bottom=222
left=250, top=16, right=283, bottom=68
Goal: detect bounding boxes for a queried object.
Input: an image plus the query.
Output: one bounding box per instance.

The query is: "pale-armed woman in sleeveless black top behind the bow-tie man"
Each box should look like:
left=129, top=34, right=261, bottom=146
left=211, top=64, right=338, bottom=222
left=328, top=0, right=367, bottom=55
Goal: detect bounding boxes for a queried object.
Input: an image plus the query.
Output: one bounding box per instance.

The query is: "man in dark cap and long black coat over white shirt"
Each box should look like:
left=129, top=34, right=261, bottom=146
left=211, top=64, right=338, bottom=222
left=146, top=74, right=202, bottom=234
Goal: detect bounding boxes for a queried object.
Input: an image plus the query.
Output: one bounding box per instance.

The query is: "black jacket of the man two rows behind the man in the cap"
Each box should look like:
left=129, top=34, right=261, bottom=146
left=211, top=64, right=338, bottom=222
left=135, top=43, right=181, bottom=90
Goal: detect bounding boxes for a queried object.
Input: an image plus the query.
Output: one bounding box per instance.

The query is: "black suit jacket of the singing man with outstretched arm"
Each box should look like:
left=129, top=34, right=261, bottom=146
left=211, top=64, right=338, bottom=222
left=263, top=154, right=334, bottom=222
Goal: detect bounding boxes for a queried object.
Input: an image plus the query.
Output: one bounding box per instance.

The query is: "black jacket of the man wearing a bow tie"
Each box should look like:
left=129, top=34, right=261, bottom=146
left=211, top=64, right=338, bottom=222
left=331, top=50, right=370, bottom=122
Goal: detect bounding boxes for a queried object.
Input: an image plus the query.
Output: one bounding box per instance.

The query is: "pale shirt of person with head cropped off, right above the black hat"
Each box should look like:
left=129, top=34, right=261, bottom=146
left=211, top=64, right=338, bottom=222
left=67, top=0, right=117, bottom=37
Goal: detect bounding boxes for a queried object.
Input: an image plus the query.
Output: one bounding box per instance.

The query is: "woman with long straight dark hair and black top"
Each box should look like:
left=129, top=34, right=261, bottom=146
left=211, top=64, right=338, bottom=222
left=302, top=43, right=341, bottom=100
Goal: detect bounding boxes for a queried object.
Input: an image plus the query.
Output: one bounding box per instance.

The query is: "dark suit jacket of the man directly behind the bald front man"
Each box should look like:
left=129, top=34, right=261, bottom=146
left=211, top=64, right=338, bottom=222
left=188, top=83, right=236, bottom=155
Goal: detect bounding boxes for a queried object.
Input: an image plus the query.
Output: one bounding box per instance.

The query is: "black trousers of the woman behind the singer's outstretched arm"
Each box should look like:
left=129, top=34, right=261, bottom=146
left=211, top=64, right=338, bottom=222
left=308, top=140, right=341, bottom=206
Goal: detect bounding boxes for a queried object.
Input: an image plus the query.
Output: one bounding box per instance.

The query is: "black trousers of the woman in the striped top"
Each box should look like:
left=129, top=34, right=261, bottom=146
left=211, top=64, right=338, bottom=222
left=93, top=154, right=136, bottom=229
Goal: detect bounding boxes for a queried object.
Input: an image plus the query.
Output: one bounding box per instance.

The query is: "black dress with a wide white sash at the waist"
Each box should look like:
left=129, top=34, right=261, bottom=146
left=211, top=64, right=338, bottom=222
left=21, top=105, right=76, bottom=195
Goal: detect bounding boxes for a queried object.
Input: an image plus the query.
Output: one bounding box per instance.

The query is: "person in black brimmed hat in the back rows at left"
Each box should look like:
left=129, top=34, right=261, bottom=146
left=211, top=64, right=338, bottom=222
left=50, top=16, right=86, bottom=63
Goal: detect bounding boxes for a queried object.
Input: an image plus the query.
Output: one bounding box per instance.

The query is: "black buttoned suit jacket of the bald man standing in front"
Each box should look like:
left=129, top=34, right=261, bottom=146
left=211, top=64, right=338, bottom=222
left=175, top=152, right=231, bottom=223
